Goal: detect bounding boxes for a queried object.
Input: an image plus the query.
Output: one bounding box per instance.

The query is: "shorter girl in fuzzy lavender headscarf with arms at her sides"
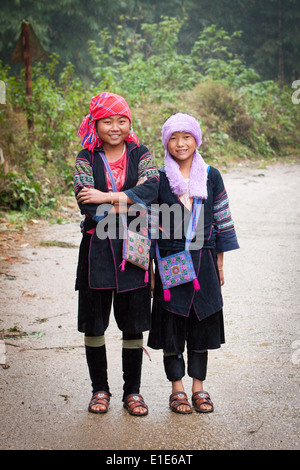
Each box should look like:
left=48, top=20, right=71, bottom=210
left=148, top=113, right=239, bottom=414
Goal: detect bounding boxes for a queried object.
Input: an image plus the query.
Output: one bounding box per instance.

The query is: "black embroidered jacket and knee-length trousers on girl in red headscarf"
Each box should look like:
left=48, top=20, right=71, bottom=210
left=74, top=144, right=159, bottom=336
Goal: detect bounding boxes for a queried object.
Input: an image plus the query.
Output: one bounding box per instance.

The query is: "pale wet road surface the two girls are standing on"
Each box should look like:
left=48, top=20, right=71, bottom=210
left=0, top=164, right=300, bottom=452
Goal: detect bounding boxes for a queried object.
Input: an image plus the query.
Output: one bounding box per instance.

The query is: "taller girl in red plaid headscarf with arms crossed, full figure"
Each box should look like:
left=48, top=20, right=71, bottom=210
left=74, top=92, right=159, bottom=416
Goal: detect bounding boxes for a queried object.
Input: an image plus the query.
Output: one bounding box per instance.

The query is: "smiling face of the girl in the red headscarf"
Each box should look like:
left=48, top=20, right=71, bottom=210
left=96, top=115, right=130, bottom=146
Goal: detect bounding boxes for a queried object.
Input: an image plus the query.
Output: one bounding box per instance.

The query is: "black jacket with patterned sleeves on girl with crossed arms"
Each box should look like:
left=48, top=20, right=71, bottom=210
left=74, top=144, right=159, bottom=292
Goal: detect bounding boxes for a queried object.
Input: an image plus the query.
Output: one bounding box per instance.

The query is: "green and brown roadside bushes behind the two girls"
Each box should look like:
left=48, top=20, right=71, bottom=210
left=0, top=17, right=300, bottom=222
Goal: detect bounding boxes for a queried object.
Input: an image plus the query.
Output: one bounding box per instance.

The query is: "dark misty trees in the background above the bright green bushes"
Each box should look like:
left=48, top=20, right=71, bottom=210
left=0, top=0, right=300, bottom=83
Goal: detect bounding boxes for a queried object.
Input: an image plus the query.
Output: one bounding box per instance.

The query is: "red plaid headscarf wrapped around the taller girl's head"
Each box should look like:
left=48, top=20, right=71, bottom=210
left=78, top=92, right=139, bottom=152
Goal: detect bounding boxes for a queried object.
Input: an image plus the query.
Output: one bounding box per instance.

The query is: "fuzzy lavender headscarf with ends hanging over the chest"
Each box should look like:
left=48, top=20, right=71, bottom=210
left=162, top=113, right=207, bottom=199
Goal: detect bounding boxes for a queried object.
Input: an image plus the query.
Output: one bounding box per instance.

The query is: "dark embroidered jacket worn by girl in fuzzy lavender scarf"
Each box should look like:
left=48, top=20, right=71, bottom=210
left=152, top=167, right=239, bottom=320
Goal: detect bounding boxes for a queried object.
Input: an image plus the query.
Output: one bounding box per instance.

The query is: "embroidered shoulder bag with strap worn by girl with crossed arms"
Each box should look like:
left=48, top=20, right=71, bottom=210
left=99, top=152, right=151, bottom=282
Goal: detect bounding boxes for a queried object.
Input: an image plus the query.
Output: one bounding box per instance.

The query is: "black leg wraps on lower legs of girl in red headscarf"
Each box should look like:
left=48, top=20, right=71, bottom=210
left=85, top=332, right=143, bottom=400
